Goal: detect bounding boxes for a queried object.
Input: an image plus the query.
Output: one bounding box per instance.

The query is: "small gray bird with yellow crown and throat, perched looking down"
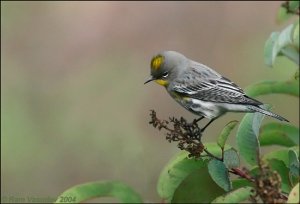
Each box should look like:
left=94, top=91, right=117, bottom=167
left=145, top=51, right=288, bottom=131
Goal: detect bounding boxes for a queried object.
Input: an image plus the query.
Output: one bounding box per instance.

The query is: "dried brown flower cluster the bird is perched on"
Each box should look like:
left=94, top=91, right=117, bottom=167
left=149, top=110, right=204, bottom=158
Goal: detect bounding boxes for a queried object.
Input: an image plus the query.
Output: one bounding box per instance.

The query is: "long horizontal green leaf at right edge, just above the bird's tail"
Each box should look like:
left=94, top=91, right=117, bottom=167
left=245, top=80, right=299, bottom=97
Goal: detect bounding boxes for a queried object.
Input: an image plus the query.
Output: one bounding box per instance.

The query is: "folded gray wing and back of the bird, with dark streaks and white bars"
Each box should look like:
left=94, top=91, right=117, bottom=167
left=170, top=62, right=262, bottom=106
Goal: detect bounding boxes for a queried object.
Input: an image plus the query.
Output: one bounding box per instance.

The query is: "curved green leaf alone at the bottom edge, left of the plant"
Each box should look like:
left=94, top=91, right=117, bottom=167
left=56, top=181, right=143, bottom=203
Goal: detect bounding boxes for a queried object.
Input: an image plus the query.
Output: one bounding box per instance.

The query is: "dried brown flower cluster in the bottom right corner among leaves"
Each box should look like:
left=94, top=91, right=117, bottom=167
left=251, top=160, right=287, bottom=203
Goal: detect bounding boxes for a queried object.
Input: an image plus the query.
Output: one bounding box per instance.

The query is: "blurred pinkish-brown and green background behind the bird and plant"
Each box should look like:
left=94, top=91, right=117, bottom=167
left=1, top=1, right=299, bottom=202
